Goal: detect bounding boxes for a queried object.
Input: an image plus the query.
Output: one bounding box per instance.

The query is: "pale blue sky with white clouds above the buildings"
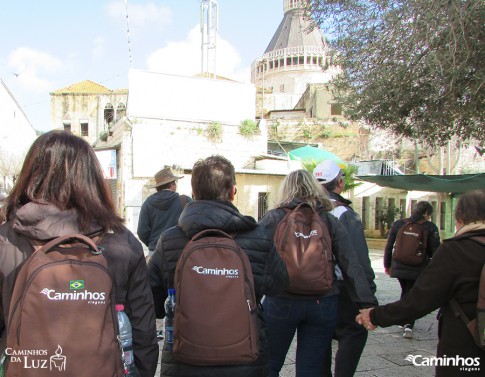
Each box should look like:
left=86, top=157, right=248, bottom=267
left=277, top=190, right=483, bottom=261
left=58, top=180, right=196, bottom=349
left=0, top=0, right=283, bottom=131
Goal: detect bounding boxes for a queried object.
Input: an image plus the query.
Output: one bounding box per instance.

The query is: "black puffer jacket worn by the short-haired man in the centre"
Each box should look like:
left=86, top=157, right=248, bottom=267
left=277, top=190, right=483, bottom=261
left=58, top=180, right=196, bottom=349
left=148, top=200, right=288, bottom=377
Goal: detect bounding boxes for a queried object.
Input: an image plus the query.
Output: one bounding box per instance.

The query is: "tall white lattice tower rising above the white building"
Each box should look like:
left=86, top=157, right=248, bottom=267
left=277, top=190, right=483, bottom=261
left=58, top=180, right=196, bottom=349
left=200, top=0, right=218, bottom=78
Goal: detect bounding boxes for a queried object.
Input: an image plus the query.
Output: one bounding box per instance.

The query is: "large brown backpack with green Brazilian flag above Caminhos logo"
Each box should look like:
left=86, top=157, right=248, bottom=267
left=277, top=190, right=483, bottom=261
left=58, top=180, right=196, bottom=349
left=6, top=234, right=123, bottom=377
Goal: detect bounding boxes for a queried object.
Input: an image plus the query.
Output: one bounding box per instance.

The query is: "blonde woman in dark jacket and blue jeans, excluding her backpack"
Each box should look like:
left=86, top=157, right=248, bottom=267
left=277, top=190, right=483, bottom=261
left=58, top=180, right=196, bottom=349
left=260, top=169, right=377, bottom=377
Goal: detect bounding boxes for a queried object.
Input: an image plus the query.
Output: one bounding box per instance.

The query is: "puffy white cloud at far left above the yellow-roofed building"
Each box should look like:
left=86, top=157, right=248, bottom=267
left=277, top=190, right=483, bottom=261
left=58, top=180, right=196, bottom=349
left=7, top=47, right=63, bottom=92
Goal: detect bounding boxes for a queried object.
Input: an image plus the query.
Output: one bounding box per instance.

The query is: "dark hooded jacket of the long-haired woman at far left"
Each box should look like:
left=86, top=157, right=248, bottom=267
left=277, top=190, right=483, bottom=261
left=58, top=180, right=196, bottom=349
left=0, top=203, right=158, bottom=377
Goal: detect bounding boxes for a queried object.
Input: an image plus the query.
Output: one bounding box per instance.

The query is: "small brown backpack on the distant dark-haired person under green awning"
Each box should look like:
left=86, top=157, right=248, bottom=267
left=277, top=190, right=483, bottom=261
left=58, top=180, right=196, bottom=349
left=392, top=219, right=428, bottom=266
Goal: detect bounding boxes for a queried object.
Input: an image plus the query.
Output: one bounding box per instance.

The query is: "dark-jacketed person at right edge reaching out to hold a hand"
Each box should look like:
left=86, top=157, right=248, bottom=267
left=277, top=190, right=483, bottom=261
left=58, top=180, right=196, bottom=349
left=356, top=189, right=485, bottom=377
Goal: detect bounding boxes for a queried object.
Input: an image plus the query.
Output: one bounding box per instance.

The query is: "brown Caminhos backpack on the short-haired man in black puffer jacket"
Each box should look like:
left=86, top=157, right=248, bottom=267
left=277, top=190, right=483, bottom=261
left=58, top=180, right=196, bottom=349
left=173, top=229, right=259, bottom=365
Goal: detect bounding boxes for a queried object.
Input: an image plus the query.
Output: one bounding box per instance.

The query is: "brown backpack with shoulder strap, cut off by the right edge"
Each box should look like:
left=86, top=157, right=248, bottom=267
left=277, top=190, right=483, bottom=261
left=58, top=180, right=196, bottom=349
left=450, top=236, right=485, bottom=350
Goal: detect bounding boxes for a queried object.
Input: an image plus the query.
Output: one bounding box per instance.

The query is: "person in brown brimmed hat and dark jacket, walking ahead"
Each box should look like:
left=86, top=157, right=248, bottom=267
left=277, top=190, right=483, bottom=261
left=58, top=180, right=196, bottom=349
left=137, top=167, right=192, bottom=257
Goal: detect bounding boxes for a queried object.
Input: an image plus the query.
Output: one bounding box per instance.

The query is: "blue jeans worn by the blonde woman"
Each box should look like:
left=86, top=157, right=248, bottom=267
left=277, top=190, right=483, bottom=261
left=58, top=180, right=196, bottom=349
left=263, top=295, right=338, bottom=377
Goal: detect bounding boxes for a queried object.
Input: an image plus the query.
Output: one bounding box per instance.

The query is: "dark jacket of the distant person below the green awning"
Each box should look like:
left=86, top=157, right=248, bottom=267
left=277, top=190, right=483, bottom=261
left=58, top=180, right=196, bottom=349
left=384, top=216, right=440, bottom=280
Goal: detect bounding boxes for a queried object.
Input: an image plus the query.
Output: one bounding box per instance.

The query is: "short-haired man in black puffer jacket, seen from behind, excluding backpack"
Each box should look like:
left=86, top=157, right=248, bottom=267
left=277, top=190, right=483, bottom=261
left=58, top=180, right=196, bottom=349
left=148, top=156, right=288, bottom=377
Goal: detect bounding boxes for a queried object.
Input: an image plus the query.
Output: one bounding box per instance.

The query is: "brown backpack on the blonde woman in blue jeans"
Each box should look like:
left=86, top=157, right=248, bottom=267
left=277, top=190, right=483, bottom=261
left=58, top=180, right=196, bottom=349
left=274, top=203, right=334, bottom=295
